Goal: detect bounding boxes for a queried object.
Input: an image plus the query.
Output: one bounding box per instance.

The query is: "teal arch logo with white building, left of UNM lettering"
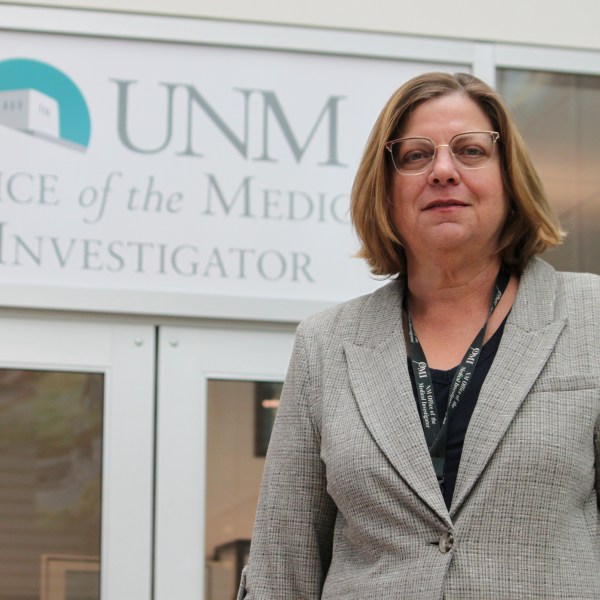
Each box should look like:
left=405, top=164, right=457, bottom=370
left=0, top=58, right=92, bottom=152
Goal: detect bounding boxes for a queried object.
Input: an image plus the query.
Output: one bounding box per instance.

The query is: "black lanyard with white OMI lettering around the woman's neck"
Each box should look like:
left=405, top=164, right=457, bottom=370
left=404, top=267, right=510, bottom=485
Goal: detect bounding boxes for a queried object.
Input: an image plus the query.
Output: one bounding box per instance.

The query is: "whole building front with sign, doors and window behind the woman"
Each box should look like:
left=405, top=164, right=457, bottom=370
left=0, top=0, right=600, bottom=600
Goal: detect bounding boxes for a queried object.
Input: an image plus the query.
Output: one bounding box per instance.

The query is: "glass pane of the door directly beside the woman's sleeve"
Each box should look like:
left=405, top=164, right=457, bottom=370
left=205, top=380, right=282, bottom=600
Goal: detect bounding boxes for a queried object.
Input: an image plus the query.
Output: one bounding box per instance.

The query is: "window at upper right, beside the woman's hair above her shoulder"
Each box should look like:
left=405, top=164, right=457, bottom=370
left=498, top=69, right=600, bottom=273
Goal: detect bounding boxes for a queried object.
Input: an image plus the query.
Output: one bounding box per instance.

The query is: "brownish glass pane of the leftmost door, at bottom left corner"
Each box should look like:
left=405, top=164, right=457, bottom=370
left=0, top=369, right=104, bottom=600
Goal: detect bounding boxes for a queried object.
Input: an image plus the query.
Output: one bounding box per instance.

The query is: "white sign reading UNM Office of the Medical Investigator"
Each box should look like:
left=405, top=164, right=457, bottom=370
left=0, top=33, right=461, bottom=316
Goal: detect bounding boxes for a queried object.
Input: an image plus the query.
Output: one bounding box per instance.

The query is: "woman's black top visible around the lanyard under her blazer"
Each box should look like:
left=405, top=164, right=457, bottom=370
left=408, top=319, right=506, bottom=508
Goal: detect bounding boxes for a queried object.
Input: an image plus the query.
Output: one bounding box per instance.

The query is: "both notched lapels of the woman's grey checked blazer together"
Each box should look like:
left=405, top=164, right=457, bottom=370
left=345, top=259, right=566, bottom=524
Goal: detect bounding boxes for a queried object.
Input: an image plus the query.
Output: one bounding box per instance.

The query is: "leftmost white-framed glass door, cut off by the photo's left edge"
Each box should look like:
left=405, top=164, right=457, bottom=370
left=0, top=312, right=155, bottom=600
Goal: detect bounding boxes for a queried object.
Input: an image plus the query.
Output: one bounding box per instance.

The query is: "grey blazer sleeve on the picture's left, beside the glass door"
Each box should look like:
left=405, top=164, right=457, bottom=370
left=238, top=325, right=336, bottom=600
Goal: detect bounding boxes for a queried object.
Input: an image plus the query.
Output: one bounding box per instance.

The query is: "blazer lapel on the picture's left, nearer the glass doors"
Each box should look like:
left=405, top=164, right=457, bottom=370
left=345, top=282, right=450, bottom=523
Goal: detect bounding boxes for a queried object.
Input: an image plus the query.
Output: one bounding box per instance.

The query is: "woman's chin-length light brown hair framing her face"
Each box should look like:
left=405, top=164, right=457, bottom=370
left=350, top=72, right=564, bottom=277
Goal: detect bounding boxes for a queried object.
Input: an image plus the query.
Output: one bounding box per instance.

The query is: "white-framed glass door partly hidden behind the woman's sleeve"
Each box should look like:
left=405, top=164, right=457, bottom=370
left=155, top=327, right=293, bottom=600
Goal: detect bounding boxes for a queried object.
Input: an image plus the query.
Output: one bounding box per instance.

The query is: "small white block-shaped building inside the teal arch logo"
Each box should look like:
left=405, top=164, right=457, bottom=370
left=0, top=89, right=60, bottom=138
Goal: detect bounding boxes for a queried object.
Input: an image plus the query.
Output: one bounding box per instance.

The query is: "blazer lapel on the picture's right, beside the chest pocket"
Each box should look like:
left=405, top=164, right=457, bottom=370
left=450, top=259, right=566, bottom=515
